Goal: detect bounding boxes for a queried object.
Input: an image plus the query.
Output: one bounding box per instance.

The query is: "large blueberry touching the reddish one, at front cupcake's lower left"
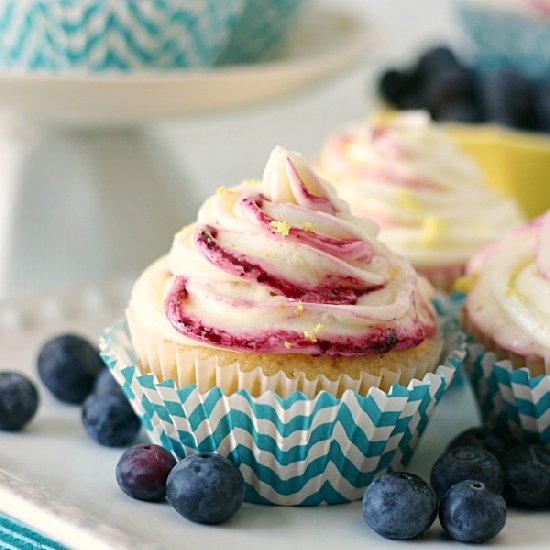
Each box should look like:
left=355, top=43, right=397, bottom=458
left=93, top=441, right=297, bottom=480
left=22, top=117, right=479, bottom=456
left=166, top=453, right=244, bottom=524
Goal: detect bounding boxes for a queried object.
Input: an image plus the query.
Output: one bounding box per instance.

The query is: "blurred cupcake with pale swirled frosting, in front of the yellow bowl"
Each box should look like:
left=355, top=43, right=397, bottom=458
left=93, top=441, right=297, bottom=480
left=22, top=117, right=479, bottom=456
left=317, top=112, right=522, bottom=290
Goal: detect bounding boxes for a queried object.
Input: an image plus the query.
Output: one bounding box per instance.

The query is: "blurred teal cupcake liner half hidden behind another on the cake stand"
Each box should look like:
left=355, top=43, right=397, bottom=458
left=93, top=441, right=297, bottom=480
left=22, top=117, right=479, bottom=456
left=218, top=0, right=304, bottom=65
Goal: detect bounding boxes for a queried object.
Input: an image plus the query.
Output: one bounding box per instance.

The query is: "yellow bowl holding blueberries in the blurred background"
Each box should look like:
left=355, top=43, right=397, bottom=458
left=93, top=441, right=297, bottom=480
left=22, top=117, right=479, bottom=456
left=446, top=124, right=550, bottom=218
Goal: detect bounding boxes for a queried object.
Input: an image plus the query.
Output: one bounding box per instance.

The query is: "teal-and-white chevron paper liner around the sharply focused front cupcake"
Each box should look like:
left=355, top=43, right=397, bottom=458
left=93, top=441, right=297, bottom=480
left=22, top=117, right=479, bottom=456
left=100, top=304, right=464, bottom=506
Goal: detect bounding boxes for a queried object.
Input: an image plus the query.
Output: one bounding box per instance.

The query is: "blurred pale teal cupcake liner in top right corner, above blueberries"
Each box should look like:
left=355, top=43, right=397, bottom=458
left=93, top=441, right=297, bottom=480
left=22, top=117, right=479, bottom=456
left=456, top=0, right=550, bottom=78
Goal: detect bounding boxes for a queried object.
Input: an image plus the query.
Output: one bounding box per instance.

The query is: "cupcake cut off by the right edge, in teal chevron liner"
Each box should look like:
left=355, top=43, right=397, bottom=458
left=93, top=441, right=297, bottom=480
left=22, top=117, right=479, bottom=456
left=463, top=211, right=550, bottom=443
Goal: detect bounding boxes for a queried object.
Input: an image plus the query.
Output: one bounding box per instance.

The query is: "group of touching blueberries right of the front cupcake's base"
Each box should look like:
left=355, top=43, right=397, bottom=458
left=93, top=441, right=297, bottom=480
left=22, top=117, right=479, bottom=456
left=363, top=428, right=550, bottom=543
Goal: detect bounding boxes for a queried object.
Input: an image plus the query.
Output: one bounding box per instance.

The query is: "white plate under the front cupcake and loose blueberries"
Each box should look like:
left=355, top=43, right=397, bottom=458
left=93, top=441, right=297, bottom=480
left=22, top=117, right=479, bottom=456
left=0, top=282, right=549, bottom=550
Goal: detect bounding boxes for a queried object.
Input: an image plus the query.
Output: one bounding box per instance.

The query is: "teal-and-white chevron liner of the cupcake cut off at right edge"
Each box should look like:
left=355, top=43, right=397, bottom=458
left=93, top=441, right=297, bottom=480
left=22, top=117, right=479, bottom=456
left=465, top=344, right=550, bottom=444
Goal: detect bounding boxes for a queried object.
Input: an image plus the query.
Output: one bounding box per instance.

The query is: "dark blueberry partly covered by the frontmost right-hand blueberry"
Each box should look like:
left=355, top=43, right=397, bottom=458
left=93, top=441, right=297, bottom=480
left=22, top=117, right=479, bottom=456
left=431, top=447, right=504, bottom=498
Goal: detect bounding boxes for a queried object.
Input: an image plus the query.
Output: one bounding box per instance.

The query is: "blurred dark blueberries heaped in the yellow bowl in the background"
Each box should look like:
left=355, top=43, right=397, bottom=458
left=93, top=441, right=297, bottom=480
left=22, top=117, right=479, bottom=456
left=378, top=46, right=550, bottom=132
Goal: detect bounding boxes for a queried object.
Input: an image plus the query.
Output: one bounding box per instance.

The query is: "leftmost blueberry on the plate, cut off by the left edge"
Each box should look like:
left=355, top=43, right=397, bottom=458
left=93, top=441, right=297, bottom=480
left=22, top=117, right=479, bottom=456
left=0, top=372, right=38, bottom=431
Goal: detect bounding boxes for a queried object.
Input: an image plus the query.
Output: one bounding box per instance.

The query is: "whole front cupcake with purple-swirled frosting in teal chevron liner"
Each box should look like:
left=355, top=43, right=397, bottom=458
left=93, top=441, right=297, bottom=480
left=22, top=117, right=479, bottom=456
left=102, top=147, right=462, bottom=505
